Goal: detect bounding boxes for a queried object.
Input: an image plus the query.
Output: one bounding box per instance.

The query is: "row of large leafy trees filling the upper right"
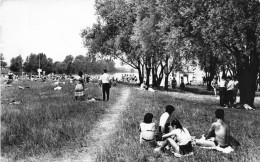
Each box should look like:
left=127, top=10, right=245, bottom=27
left=82, top=0, right=260, bottom=106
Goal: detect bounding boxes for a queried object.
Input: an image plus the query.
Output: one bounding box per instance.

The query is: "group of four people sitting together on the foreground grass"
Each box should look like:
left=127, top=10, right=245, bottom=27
left=139, top=105, right=234, bottom=157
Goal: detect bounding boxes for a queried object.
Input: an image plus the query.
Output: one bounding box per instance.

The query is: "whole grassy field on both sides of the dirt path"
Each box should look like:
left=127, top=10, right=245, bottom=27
left=1, top=78, right=260, bottom=162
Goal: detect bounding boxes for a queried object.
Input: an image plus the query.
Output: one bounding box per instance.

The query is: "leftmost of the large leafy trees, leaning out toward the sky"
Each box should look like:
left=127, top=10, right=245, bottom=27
left=82, top=0, right=146, bottom=82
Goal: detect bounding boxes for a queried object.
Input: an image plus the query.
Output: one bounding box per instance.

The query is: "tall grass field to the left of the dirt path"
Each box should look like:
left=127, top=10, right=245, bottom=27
left=1, top=81, right=120, bottom=160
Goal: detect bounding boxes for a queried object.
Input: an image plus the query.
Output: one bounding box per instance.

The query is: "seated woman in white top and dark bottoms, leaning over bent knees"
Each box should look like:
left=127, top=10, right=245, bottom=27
left=154, top=119, right=193, bottom=157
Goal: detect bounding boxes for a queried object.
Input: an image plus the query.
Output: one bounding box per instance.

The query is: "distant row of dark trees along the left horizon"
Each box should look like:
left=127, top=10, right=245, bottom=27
left=1, top=53, right=116, bottom=74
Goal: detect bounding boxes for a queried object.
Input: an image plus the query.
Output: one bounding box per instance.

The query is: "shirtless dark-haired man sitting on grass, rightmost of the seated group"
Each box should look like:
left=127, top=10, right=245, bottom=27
left=195, top=109, right=232, bottom=151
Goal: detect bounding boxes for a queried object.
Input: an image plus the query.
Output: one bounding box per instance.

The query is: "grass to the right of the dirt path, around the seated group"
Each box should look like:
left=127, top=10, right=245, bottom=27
left=97, top=89, right=260, bottom=162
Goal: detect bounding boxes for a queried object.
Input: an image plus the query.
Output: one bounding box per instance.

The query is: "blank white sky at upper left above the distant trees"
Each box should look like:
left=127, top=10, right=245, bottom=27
left=0, top=0, right=96, bottom=65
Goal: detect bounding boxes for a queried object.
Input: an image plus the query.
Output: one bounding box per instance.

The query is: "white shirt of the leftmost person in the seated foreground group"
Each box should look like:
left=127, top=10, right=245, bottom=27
left=140, top=122, right=155, bottom=140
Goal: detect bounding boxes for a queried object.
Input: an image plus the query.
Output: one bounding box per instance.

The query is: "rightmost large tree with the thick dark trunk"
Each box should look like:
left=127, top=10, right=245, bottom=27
left=189, top=0, right=260, bottom=106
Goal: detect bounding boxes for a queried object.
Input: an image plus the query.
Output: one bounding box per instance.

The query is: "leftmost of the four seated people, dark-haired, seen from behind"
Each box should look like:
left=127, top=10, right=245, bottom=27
left=139, top=113, right=156, bottom=146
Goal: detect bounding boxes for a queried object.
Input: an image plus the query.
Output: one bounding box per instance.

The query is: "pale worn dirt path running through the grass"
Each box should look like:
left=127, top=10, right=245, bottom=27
left=57, top=88, right=130, bottom=162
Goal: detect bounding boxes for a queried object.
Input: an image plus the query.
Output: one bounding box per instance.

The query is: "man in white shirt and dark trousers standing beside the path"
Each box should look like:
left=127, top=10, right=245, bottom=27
left=99, top=69, right=111, bottom=101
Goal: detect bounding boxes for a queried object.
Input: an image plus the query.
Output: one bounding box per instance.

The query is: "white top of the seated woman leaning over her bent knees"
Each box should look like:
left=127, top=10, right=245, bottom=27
left=163, top=127, right=191, bottom=145
